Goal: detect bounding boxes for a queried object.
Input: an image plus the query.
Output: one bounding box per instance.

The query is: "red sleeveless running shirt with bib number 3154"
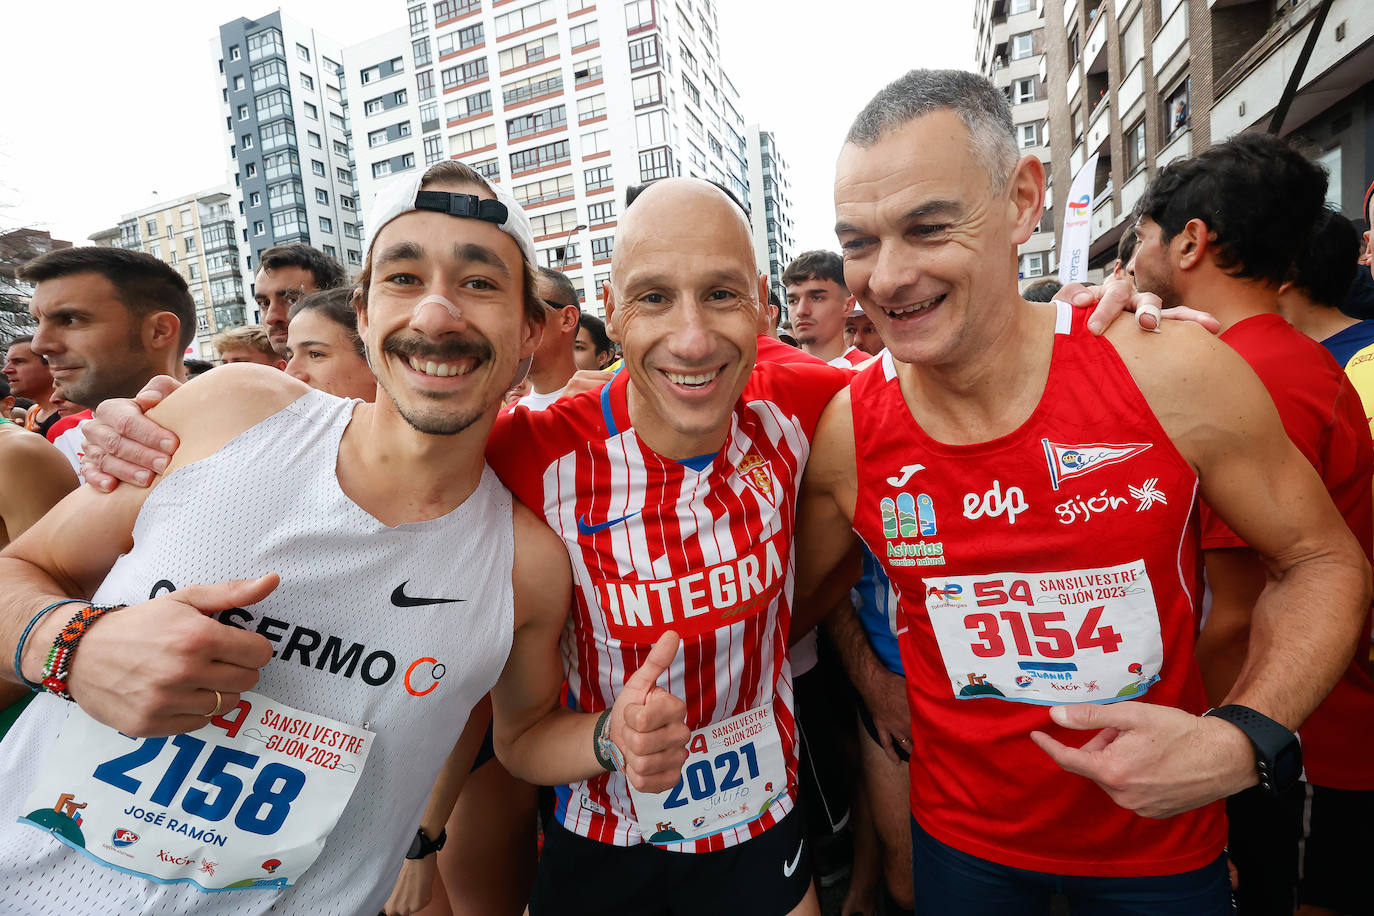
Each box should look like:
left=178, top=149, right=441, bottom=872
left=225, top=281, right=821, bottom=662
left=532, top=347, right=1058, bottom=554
left=851, top=306, right=1226, bottom=876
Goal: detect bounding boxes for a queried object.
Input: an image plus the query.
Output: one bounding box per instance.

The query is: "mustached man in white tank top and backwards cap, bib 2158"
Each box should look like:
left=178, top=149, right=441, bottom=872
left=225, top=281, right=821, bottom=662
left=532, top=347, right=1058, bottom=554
left=0, top=162, right=686, bottom=915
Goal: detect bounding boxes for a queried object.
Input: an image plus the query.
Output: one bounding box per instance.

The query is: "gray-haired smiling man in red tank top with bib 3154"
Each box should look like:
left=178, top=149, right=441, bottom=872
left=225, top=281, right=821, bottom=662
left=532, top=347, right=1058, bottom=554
left=797, top=70, right=1370, bottom=915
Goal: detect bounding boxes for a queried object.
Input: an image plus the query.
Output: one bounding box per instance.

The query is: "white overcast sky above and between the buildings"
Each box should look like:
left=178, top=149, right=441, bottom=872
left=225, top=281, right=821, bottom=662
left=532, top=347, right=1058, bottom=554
left=0, top=0, right=973, bottom=251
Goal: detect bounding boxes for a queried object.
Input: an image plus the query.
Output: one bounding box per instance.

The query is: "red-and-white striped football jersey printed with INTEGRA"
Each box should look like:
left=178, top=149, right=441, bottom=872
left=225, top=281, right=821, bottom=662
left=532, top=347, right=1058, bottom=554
left=486, top=364, right=849, bottom=853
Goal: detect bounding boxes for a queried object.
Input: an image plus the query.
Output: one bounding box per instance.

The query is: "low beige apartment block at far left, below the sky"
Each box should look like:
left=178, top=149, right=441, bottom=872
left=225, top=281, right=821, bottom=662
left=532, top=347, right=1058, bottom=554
left=88, top=185, right=250, bottom=360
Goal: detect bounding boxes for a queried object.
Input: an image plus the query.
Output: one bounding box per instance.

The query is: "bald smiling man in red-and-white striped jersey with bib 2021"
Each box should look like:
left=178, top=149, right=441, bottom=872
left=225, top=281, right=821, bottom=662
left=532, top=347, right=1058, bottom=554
left=488, top=180, right=848, bottom=916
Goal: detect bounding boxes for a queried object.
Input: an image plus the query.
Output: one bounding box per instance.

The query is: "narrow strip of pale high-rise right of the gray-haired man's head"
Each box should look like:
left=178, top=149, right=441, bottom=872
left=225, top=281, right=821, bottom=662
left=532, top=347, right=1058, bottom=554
left=973, top=0, right=1062, bottom=286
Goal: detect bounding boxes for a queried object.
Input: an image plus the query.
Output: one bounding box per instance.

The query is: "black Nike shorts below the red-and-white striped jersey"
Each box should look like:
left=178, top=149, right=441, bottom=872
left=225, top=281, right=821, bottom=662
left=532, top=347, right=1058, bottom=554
left=529, top=810, right=811, bottom=916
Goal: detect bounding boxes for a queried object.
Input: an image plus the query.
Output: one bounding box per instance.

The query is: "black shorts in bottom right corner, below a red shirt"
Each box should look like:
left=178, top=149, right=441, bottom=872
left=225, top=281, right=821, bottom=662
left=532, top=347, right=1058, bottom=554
left=1297, top=786, right=1374, bottom=913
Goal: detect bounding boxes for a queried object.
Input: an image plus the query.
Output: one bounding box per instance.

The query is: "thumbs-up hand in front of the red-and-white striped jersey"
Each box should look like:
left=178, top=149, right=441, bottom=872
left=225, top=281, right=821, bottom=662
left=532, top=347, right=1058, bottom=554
left=609, top=630, right=691, bottom=792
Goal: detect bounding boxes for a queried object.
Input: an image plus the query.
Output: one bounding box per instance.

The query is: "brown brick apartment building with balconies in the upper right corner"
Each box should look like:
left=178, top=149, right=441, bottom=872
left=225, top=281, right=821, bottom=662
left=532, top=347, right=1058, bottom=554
left=1044, top=0, right=1374, bottom=276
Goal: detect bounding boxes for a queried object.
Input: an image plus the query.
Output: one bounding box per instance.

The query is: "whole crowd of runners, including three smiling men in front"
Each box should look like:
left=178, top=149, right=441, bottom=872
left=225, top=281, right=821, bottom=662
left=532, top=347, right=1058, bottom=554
left=0, top=70, right=1374, bottom=916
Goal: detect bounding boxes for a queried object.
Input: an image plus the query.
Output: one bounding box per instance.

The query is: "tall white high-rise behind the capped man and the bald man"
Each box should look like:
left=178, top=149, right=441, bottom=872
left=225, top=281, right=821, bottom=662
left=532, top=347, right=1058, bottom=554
left=344, top=0, right=749, bottom=314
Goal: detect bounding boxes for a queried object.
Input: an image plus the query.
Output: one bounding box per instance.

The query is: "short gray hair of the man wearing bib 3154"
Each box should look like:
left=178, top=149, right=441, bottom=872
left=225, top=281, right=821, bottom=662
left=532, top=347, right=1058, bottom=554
left=845, top=70, right=1018, bottom=187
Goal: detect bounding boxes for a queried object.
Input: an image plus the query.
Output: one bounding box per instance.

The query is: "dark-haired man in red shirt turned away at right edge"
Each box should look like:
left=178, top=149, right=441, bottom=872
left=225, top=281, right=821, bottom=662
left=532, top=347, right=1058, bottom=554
left=1134, top=133, right=1374, bottom=916
